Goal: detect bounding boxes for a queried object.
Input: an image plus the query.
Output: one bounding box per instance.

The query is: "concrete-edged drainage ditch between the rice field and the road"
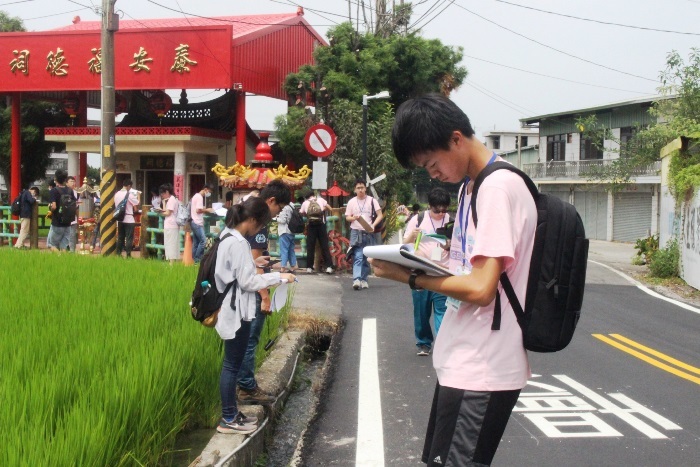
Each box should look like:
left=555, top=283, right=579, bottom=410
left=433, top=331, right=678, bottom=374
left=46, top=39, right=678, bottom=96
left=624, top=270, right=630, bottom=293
left=169, top=314, right=340, bottom=467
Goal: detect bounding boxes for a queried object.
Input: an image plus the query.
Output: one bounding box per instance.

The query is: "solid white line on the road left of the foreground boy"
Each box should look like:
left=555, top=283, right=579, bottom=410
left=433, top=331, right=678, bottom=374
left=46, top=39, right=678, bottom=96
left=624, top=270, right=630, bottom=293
left=355, top=319, right=384, bottom=467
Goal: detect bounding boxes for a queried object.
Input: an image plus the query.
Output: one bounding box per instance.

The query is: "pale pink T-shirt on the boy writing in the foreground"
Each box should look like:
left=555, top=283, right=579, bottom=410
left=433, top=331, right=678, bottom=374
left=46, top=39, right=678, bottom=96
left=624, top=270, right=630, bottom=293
left=433, top=170, right=537, bottom=391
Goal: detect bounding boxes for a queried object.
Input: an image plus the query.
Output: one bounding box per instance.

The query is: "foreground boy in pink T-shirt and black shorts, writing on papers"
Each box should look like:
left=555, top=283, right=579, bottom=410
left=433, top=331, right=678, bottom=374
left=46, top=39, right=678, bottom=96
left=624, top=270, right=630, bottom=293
left=372, top=95, right=537, bottom=466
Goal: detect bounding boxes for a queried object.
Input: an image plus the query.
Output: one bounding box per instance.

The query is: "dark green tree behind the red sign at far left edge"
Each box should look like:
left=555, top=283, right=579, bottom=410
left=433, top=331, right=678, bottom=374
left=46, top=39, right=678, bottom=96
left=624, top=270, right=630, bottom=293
left=0, top=11, right=69, bottom=186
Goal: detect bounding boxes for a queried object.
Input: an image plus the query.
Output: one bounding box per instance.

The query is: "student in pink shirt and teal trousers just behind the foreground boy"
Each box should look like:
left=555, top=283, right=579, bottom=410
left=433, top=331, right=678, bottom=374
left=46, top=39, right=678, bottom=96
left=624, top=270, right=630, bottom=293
left=403, top=187, right=450, bottom=357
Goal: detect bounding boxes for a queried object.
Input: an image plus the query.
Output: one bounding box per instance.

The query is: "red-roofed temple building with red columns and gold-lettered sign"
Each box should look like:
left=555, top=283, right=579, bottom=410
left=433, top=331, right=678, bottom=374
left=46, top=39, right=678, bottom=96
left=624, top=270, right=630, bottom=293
left=0, top=9, right=326, bottom=199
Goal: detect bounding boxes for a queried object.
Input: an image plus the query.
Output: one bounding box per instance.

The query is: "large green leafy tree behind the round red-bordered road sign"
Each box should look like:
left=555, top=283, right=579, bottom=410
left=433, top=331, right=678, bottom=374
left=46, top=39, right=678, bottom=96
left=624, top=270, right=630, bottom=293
left=275, top=20, right=467, bottom=205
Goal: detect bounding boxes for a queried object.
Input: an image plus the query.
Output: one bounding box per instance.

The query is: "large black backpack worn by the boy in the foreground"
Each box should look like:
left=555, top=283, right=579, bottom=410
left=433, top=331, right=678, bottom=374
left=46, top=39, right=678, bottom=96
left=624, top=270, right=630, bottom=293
left=465, top=162, right=588, bottom=352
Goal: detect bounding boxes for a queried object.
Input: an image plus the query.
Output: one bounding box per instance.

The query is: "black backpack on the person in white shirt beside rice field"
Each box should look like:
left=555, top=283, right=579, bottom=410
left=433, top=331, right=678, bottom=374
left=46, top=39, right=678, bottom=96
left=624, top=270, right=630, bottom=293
left=190, top=233, right=236, bottom=328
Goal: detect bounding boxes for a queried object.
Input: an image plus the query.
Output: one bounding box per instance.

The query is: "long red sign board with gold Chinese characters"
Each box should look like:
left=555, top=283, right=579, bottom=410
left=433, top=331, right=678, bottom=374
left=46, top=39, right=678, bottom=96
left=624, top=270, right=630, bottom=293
left=0, top=26, right=233, bottom=94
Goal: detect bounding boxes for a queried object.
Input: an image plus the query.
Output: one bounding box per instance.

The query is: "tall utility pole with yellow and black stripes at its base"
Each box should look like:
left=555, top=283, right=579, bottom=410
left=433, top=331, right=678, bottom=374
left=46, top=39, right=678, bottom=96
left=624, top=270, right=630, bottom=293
left=100, top=0, right=119, bottom=256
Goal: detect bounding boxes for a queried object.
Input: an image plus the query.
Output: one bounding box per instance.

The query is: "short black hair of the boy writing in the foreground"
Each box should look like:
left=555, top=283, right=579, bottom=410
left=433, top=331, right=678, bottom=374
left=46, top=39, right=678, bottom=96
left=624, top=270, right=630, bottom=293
left=391, top=94, right=474, bottom=168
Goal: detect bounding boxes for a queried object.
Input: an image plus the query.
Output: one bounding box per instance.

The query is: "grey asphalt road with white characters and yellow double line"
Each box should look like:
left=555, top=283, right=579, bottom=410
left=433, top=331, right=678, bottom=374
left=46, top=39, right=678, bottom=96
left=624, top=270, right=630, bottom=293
left=303, top=263, right=700, bottom=466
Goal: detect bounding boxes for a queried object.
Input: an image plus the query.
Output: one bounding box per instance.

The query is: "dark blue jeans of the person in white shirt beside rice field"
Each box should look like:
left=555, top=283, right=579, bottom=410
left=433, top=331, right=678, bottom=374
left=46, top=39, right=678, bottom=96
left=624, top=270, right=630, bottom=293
left=219, top=321, right=250, bottom=420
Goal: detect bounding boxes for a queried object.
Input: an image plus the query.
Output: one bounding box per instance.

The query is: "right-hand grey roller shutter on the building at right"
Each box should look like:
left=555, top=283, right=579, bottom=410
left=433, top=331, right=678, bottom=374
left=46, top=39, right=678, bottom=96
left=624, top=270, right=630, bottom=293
left=613, top=192, right=651, bottom=242
